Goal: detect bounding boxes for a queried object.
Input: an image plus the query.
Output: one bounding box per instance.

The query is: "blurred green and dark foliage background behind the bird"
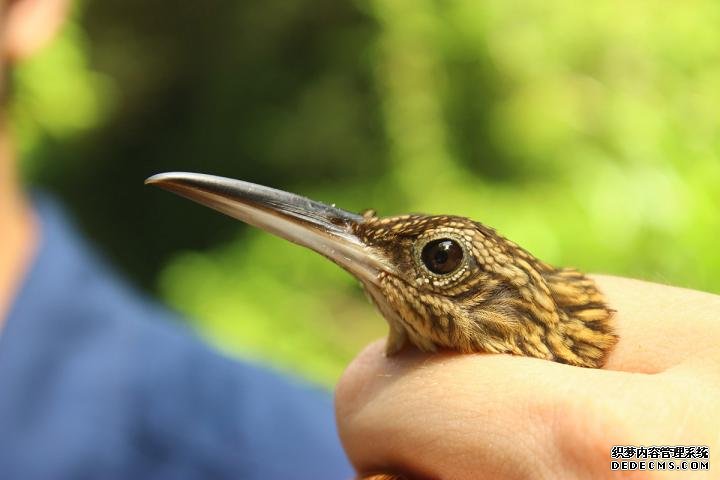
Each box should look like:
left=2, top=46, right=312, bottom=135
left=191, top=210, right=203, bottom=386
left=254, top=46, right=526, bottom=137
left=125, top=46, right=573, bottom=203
left=13, top=0, right=720, bottom=385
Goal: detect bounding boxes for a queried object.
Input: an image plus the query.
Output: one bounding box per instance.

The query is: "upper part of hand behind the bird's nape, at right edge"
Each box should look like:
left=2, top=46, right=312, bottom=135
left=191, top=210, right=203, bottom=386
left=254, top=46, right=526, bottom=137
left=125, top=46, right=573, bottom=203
left=593, top=276, right=720, bottom=373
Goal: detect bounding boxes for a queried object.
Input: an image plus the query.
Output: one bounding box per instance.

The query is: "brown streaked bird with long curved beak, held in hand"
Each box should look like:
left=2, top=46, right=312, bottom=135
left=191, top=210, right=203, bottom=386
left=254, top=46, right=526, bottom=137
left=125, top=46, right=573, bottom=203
left=145, top=172, right=618, bottom=368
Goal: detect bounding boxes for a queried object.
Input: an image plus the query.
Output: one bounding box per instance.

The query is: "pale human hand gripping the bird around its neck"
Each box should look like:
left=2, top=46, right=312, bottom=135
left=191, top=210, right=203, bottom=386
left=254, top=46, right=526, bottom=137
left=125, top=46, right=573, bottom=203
left=336, top=276, right=720, bottom=480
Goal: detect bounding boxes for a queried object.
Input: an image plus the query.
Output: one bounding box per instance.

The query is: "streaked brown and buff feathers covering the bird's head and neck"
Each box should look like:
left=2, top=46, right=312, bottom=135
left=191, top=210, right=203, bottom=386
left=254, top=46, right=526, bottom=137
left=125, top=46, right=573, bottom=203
left=356, top=215, right=617, bottom=368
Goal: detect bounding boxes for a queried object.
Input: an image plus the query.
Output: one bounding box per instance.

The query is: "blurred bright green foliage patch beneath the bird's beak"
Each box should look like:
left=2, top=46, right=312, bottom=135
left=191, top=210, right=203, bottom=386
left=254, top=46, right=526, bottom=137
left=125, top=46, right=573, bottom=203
left=161, top=229, right=382, bottom=382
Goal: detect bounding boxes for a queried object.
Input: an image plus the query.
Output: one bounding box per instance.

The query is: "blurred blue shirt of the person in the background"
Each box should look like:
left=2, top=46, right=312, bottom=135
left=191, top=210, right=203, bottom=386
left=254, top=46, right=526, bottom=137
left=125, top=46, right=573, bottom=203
left=0, top=199, right=352, bottom=480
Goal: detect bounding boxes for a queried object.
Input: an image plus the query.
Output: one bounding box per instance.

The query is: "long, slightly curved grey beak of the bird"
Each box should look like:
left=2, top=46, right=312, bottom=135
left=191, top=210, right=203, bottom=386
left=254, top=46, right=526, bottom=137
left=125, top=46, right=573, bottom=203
left=145, top=172, right=390, bottom=284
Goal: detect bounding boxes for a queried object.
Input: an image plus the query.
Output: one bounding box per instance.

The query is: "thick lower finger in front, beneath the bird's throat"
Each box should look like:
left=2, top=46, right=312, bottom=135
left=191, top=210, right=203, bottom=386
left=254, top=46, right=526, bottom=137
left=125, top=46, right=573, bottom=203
left=337, top=342, right=720, bottom=479
